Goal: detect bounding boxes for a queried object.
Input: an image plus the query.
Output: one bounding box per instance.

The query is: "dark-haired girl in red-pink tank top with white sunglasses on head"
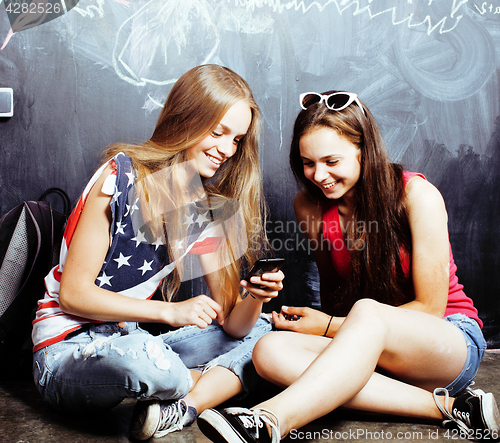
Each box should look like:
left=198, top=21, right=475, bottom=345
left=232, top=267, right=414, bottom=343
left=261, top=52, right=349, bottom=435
left=198, top=91, right=500, bottom=443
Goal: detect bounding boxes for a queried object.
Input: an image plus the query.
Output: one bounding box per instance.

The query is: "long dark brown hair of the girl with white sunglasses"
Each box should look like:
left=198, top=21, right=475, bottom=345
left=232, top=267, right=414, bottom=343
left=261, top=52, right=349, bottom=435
left=290, top=91, right=412, bottom=315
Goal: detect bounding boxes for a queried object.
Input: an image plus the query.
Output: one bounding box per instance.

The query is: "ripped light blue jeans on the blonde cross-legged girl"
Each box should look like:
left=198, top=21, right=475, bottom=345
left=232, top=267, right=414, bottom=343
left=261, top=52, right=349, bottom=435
left=33, top=317, right=272, bottom=412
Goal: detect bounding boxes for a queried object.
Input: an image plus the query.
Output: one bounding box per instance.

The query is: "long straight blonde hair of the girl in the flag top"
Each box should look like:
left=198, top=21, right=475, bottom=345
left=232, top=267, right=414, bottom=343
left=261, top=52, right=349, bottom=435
left=103, top=65, right=266, bottom=313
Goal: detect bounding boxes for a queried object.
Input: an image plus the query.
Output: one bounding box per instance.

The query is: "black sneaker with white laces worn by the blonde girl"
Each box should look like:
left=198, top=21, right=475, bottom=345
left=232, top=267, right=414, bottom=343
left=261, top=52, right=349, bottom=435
left=130, top=400, right=191, bottom=440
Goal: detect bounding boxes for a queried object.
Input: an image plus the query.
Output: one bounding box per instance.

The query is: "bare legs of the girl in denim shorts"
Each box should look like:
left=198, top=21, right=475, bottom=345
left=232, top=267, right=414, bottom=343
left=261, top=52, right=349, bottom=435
left=254, top=300, right=467, bottom=435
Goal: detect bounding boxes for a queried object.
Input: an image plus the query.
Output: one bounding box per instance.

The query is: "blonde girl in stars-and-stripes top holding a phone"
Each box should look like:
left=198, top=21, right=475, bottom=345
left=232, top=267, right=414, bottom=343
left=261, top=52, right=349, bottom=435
left=33, top=65, right=284, bottom=440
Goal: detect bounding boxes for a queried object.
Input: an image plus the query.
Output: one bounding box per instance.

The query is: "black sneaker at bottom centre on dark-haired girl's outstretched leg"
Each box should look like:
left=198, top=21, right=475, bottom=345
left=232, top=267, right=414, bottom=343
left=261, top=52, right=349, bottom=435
left=198, top=408, right=281, bottom=443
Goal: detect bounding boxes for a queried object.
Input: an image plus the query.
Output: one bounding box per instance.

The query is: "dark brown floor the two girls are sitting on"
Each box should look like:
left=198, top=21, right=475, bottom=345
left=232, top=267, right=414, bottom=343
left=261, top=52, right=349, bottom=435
left=0, top=350, right=500, bottom=443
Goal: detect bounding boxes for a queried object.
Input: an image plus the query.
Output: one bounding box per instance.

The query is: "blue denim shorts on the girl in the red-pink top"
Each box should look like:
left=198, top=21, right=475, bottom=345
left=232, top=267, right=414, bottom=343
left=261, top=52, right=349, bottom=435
left=444, top=314, right=486, bottom=397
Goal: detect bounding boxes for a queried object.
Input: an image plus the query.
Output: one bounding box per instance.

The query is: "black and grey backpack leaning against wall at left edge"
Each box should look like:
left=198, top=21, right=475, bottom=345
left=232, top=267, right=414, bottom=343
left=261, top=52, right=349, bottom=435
left=0, top=188, right=71, bottom=379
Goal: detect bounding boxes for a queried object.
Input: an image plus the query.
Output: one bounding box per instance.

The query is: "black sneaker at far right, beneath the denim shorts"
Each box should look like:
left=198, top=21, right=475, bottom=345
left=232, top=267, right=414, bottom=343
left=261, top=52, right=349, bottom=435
left=434, top=388, right=500, bottom=440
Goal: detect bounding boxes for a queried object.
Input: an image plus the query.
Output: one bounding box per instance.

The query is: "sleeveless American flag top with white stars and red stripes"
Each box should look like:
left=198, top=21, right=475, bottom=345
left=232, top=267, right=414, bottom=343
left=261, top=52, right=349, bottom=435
left=32, top=153, right=221, bottom=351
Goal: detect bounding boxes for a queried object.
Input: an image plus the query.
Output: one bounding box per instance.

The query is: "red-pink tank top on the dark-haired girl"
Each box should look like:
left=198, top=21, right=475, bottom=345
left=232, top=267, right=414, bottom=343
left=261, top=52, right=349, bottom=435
left=323, top=171, right=483, bottom=328
